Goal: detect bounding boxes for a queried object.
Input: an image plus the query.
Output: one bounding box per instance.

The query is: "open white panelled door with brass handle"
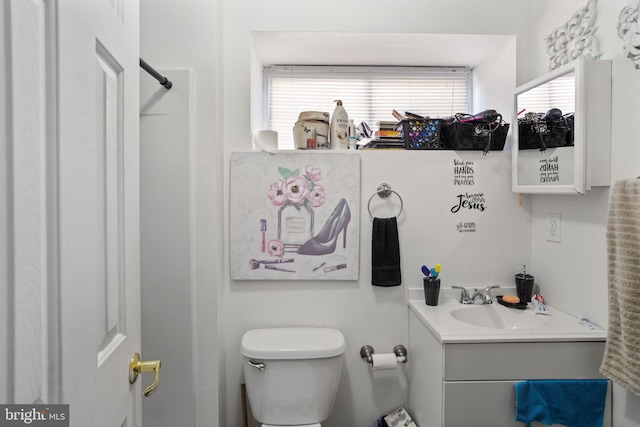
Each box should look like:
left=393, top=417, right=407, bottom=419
left=0, top=0, right=146, bottom=427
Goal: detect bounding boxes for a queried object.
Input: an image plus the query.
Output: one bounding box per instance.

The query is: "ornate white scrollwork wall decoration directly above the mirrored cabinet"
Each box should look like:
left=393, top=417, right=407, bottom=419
left=544, top=0, right=601, bottom=70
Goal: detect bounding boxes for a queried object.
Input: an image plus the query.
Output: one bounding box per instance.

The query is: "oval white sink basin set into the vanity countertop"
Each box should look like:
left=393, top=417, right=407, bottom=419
left=451, top=303, right=548, bottom=330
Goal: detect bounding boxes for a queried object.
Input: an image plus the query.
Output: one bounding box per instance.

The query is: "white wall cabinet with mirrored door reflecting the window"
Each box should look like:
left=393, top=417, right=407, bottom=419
left=512, top=58, right=611, bottom=194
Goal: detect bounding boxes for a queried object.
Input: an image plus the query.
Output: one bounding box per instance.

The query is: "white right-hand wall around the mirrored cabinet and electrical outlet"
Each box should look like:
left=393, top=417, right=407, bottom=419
left=531, top=0, right=640, bottom=427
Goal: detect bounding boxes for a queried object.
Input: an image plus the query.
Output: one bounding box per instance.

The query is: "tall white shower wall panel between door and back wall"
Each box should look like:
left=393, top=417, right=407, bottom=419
left=140, top=68, right=196, bottom=427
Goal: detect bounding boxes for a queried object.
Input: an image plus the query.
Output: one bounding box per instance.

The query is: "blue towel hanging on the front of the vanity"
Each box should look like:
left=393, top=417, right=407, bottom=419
left=515, top=380, right=607, bottom=427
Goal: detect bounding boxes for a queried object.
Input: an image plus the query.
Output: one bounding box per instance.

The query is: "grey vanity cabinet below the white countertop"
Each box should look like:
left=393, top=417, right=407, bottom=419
left=407, top=310, right=611, bottom=427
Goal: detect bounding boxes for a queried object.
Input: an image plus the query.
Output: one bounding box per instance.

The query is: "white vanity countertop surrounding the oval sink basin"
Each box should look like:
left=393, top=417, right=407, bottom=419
left=409, top=289, right=607, bottom=343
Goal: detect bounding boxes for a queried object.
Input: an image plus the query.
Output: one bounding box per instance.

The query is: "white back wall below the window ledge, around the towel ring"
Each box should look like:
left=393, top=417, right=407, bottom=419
left=226, top=151, right=530, bottom=427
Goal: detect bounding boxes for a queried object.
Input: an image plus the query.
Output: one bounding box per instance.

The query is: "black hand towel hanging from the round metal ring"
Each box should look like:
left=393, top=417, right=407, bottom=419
left=371, top=217, right=402, bottom=286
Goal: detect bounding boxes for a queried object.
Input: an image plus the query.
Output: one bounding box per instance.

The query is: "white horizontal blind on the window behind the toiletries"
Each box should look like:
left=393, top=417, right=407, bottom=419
left=264, top=65, right=471, bottom=149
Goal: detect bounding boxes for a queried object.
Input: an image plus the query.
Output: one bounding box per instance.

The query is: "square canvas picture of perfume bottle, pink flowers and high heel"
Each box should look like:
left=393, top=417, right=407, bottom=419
left=230, top=152, right=360, bottom=280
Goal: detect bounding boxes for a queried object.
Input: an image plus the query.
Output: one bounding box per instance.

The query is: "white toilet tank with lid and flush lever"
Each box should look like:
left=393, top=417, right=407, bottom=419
left=240, top=327, right=346, bottom=427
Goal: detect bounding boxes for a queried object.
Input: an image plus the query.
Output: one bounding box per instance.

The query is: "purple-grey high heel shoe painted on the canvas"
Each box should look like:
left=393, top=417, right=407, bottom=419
left=298, top=199, right=351, bottom=255
